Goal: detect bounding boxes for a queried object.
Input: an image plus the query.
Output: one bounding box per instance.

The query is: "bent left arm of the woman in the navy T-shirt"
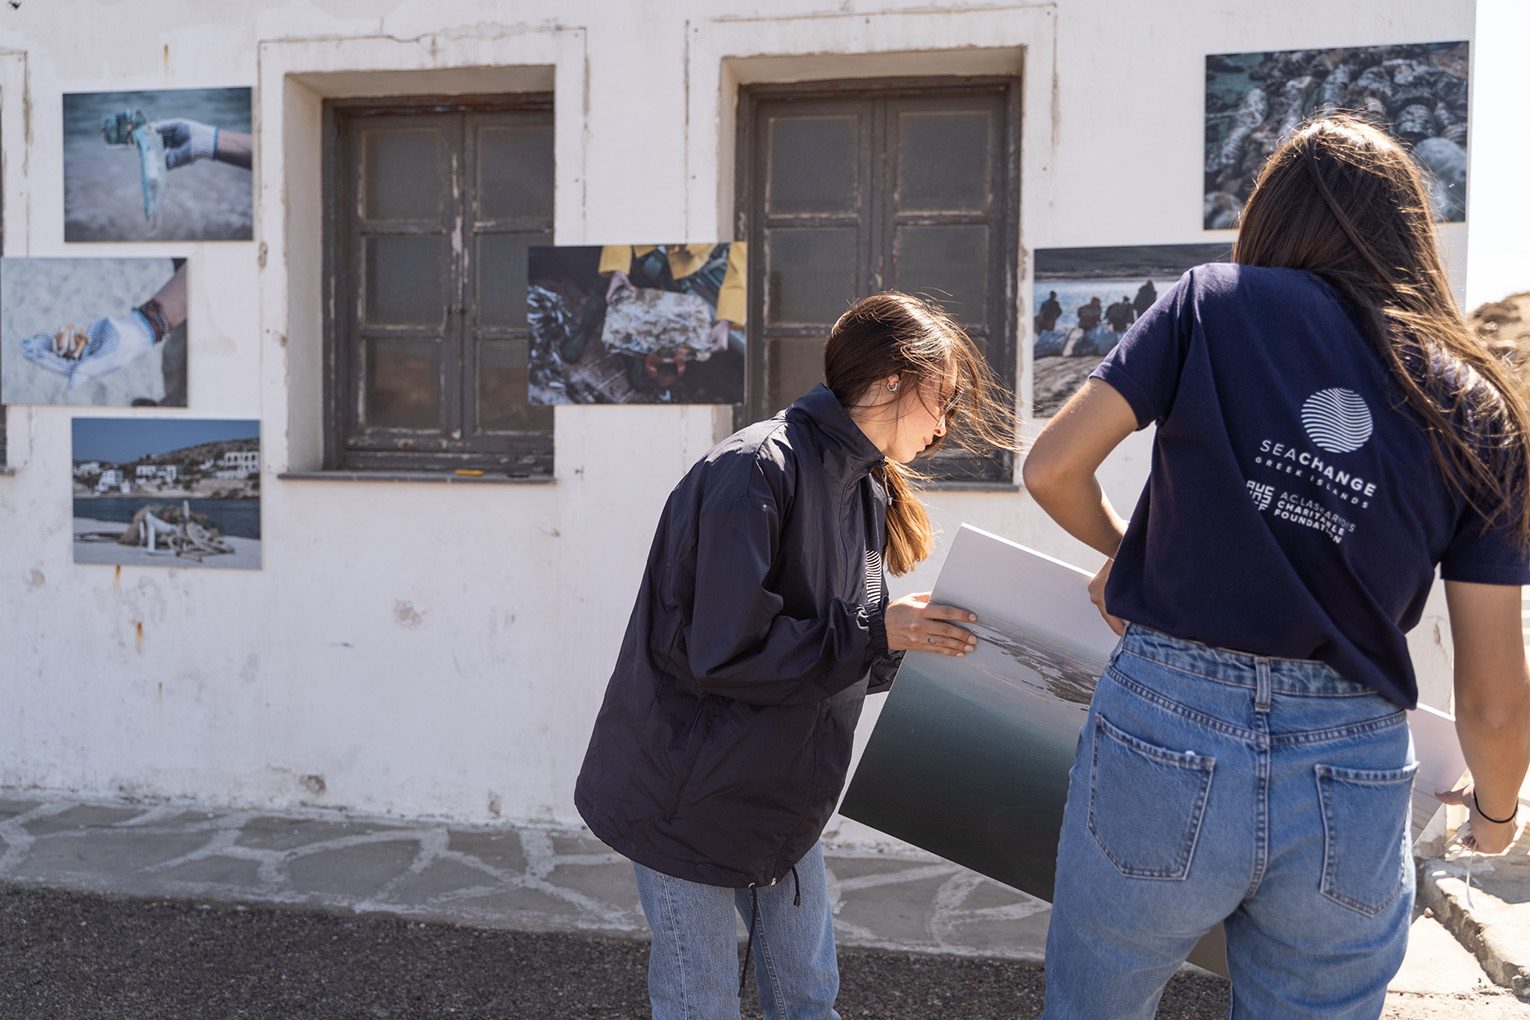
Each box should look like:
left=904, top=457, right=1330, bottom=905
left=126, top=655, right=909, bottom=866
left=1022, top=379, right=1137, bottom=557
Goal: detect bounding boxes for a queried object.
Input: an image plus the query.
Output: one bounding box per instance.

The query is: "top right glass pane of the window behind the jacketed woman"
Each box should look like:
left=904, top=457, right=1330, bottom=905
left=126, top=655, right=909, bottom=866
left=898, top=112, right=993, bottom=213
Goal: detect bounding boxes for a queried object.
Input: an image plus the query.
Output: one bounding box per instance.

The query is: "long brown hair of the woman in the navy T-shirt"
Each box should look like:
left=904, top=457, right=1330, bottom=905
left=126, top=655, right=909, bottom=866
left=1233, top=115, right=1530, bottom=547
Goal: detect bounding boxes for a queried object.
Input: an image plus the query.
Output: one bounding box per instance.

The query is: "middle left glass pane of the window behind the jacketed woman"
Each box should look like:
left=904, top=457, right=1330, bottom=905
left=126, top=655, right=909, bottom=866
left=765, top=226, right=858, bottom=323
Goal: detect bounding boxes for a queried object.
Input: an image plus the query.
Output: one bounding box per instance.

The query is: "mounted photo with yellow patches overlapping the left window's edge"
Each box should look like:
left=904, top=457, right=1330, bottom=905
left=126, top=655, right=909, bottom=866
left=526, top=242, right=748, bottom=404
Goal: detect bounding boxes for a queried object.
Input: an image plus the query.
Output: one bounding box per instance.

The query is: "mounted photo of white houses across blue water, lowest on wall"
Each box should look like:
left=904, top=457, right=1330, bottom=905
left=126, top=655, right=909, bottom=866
left=72, top=417, right=260, bottom=570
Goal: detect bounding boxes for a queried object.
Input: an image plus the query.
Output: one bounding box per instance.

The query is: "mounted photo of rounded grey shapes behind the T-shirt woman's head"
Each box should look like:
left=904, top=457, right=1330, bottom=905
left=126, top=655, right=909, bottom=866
left=1204, top=41, right=1470, bottom=229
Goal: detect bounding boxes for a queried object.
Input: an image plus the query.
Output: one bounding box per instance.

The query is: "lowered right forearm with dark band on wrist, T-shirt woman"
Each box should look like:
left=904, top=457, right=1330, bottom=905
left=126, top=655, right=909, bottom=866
left=1441, top=581, right=1530, bottom=853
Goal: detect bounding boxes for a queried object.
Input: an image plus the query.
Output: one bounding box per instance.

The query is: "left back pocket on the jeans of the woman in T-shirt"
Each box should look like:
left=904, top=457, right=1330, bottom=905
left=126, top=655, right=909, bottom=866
left=1089, top=714, right=1216, bottom=879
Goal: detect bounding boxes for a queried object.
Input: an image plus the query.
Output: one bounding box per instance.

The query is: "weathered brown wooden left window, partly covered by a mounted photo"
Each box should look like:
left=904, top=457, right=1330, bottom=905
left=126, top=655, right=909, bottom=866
left=324, top=95, right=552, bottom=476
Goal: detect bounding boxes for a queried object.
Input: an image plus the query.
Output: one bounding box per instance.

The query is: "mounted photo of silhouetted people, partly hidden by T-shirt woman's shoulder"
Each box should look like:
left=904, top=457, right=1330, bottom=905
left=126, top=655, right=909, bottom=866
left=1031, top=245, right=1232, bottom=417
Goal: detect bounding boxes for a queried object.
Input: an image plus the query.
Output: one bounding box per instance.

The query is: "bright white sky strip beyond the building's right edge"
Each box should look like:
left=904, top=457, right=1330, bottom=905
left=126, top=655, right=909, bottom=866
left=1466, top=0, right=1530, bottom=310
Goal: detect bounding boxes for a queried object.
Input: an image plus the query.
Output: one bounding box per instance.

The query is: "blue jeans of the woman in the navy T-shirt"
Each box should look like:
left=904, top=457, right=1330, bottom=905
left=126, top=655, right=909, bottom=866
left=1042, top=624, right=1417, bottom=1020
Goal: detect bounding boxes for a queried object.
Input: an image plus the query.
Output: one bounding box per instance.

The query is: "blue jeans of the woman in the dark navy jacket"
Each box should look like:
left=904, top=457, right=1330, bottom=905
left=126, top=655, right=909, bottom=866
left=633, top=843, right=840, bottom=1020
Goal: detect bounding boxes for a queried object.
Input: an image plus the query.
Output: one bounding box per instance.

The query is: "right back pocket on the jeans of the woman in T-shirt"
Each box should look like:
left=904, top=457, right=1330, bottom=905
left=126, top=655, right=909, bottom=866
left=1313, top=763, right=1418, bottom=918
